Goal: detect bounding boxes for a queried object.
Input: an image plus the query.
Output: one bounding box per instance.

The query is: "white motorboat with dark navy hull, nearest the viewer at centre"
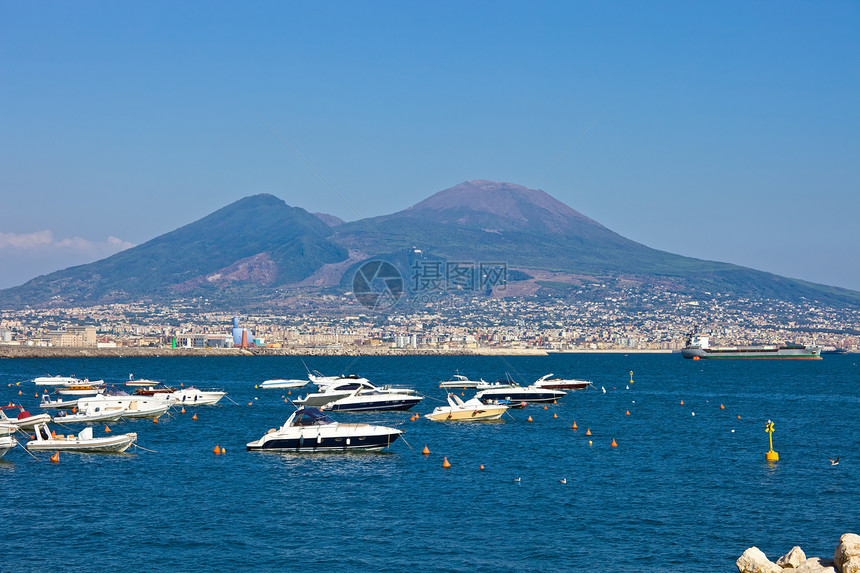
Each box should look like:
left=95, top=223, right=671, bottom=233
left=246, top=408, right=403, bottom=452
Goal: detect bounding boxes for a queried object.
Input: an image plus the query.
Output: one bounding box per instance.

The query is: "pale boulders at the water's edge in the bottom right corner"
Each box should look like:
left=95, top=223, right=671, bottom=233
left=735, top=533, right=860, bottom=573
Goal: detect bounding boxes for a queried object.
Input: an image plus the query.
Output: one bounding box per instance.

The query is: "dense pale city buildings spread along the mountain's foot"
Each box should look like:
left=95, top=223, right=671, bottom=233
left=0, top=289, right=860, bottom=354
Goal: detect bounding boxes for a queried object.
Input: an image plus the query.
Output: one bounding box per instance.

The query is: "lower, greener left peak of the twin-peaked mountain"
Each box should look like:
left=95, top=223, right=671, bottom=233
left=0, top=194, right=347, bottom=305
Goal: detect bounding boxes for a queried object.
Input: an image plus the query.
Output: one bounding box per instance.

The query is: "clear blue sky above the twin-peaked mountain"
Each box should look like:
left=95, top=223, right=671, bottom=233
left=0, top=0, right=860, bottom=290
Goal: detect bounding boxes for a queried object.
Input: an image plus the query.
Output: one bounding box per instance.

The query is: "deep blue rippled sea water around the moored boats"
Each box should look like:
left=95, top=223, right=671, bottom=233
left=0, top=354, right=860, bottom=572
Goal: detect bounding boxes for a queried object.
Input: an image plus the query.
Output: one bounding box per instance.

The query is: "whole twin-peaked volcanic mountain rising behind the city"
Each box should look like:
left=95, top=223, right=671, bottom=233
left=0, top=180, right=860, bottom=307
